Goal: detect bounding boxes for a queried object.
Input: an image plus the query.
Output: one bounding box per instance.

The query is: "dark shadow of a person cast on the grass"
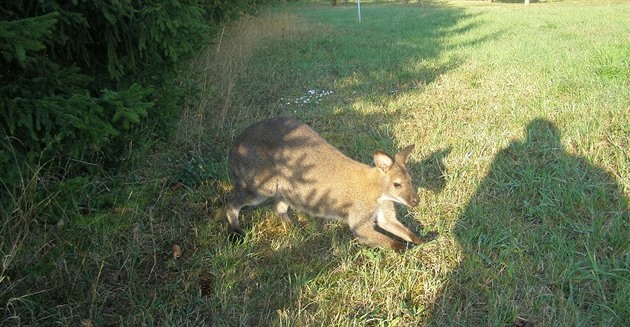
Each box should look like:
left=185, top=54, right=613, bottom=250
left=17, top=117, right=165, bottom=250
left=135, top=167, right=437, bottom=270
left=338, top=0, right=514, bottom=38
left=430, top=119, right=630, bottom=326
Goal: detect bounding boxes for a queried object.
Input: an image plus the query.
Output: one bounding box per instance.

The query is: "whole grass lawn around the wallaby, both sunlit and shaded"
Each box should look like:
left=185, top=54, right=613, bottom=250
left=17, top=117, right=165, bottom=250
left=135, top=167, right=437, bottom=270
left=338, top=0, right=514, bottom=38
left=0, top=1, right=630, bottom=326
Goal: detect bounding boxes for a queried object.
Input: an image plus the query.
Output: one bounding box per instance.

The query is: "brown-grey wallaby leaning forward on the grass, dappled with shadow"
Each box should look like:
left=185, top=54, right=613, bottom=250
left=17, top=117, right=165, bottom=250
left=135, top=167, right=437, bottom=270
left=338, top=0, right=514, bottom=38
left=226, top=117, right=421, bottom=251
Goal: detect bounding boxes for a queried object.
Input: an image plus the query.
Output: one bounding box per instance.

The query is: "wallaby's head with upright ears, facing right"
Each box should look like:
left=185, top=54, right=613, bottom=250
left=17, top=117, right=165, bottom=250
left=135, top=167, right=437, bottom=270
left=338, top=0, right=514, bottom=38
left=374, top=145, right=420, bottom=207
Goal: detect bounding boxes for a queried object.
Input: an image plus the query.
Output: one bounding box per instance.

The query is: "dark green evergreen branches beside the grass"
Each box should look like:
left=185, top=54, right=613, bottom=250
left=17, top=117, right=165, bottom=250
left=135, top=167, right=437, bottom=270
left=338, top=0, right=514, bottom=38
left=0, top=0, right=261, bottom=190
